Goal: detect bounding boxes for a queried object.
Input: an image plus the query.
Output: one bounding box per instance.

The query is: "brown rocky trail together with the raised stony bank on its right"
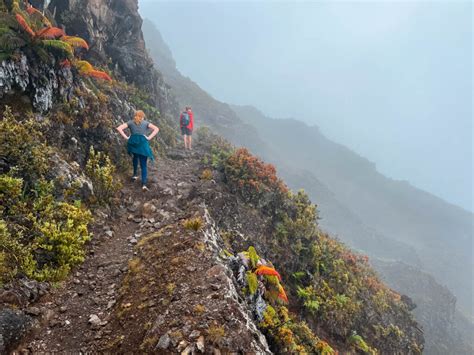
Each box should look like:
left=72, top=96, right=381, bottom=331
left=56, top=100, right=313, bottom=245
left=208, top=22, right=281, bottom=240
left=18, top=146, right=270, bottom=354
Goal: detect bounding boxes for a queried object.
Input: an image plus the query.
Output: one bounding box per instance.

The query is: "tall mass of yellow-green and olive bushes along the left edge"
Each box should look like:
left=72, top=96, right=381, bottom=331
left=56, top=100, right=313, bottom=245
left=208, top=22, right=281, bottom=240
left=0, top=108, right=92, bottom=283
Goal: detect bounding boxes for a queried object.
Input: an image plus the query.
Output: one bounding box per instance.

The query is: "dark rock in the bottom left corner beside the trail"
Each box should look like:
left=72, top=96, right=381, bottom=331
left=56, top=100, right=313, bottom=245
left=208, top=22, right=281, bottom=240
left=0, top=308, right=31, bottom=354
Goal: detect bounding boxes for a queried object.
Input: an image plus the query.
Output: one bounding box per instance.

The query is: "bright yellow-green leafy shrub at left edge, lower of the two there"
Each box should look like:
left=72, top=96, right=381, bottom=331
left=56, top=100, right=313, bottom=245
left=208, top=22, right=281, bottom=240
left=0, top=175, right=92, bottom=282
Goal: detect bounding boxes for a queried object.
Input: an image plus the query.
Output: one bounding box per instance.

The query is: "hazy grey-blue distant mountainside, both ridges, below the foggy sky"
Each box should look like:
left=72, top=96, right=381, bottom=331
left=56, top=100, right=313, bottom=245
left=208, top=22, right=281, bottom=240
left=143, top=20, right=473, bottom=353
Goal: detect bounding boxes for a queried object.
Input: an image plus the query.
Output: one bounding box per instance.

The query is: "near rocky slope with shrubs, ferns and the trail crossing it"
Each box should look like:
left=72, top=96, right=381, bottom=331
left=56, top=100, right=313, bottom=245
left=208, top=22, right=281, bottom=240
left=0, top=0, right=424, bottom=354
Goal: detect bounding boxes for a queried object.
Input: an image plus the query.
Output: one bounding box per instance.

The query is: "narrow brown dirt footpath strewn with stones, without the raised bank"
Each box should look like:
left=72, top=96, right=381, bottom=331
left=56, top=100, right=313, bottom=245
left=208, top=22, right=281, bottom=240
left=20, top=151, right=199, bottom=353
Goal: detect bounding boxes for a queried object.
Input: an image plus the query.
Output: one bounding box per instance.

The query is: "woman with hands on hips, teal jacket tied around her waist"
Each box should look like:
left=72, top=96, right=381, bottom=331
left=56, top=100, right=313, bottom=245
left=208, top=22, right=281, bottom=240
left=117, top=110, right=160, bottom=191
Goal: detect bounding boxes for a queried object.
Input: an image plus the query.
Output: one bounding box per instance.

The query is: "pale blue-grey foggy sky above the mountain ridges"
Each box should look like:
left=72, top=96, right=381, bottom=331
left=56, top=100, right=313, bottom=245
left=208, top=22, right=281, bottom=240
left=140, top=0, right=474, bottom=211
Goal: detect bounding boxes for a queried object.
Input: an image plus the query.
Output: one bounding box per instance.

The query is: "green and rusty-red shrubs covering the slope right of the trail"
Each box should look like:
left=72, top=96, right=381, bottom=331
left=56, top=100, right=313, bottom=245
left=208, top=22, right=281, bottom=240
left=201, top=132, right=423, bottom=353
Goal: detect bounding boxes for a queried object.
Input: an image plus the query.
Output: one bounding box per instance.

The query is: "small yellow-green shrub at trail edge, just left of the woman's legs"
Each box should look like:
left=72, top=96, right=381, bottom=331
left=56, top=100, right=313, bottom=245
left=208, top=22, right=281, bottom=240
left=85, top=146, right=121, bottom=205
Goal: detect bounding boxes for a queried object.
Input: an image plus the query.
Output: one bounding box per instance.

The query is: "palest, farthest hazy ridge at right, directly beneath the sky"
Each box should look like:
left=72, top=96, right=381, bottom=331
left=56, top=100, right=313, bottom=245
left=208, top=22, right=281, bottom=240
left=235, top=103, right=474, bottom=315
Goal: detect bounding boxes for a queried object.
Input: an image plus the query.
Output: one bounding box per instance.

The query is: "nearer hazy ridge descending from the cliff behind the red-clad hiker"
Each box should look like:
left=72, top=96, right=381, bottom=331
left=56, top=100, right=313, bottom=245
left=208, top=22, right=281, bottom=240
left=143, top=19, right=419, bottom=264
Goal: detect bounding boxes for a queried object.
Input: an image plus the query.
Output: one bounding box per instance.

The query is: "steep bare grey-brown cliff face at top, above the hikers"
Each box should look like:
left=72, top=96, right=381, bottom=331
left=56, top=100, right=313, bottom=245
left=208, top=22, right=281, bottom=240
left=49, top=0, right=178, bottom=115
